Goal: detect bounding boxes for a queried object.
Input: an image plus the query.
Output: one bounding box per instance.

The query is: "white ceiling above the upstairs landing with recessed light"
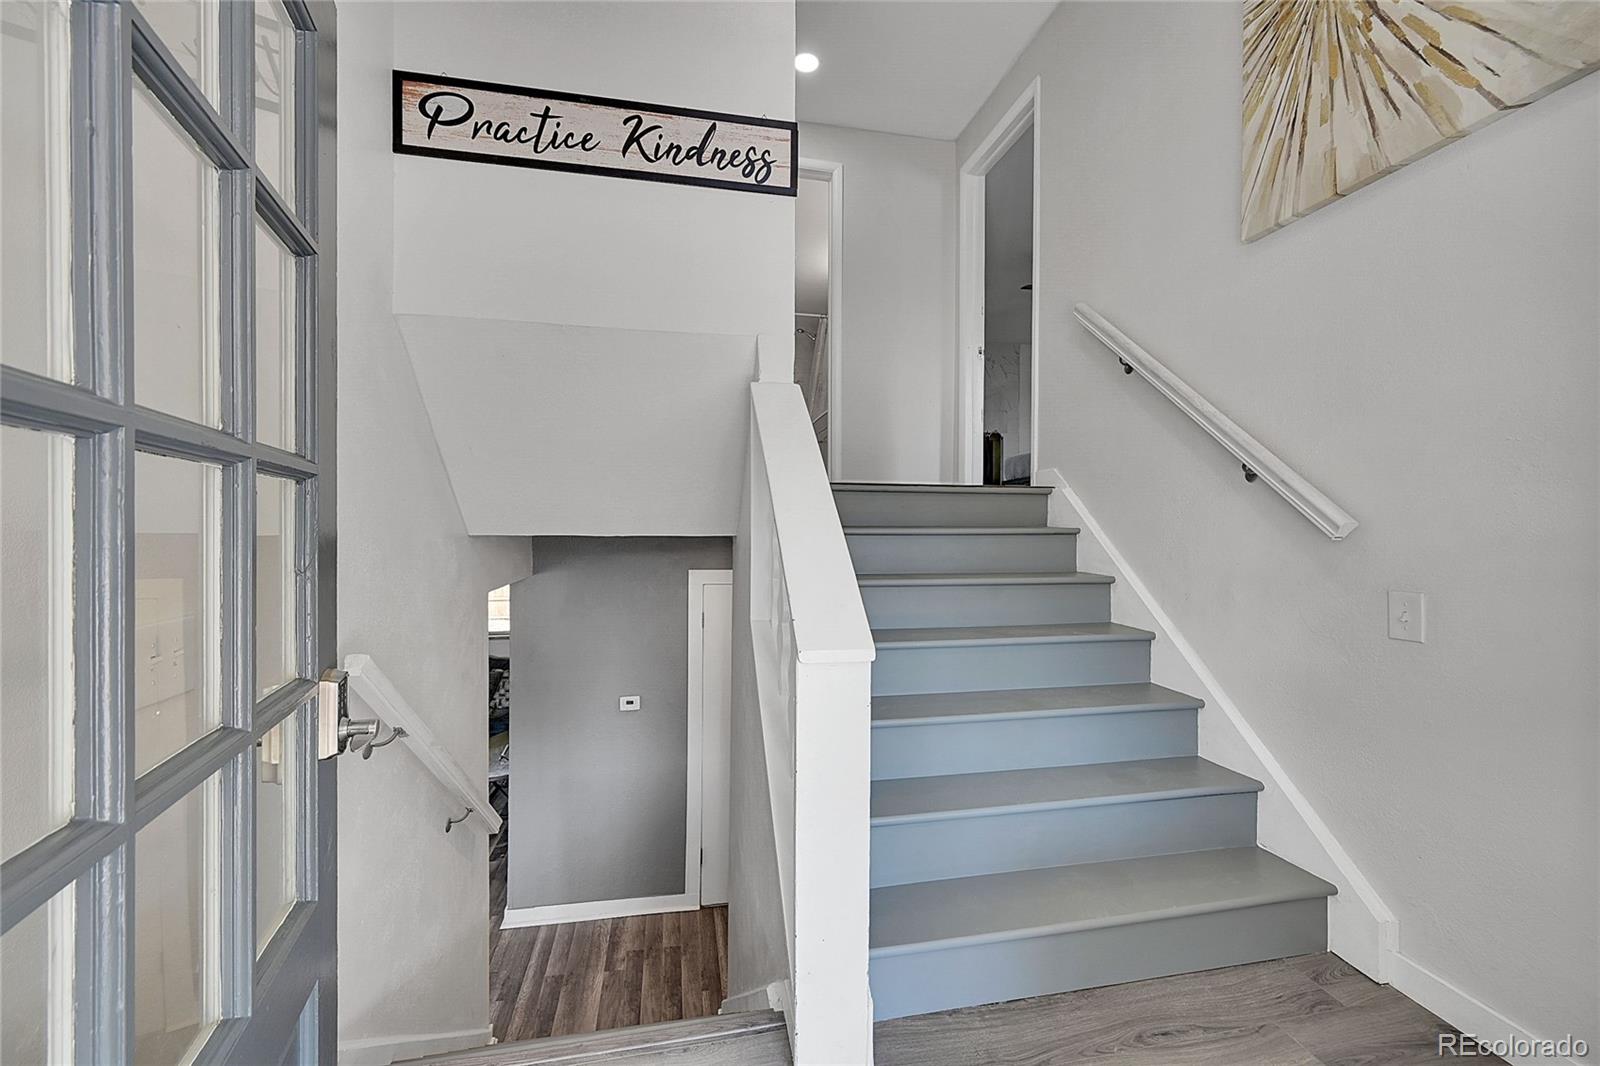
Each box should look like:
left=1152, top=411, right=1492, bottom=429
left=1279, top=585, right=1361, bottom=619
left=795, top=0, right=1056, bottom=141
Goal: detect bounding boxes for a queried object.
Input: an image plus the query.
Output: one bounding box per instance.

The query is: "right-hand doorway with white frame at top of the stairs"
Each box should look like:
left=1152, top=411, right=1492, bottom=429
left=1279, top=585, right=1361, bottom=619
left=957, top=80, right=1040, bottom=485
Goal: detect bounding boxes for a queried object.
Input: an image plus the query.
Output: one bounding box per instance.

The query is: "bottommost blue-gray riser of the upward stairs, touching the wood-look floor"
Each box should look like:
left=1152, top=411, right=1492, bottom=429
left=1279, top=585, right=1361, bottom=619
left=869, top=898, right=1328, bottom=1021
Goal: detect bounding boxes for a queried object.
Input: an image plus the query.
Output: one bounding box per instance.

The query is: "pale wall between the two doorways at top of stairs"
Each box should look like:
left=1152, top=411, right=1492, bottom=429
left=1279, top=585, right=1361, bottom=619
left=800, top=123, right=957, bottom=482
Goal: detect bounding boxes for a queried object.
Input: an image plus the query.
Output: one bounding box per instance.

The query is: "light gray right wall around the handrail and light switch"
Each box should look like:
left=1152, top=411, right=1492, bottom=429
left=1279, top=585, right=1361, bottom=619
left=960, top=3, right=1600, bottom=1044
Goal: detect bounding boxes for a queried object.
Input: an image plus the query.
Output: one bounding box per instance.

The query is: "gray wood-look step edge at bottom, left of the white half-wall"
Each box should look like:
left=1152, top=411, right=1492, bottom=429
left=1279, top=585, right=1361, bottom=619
left=410, top=1010, right=784, bottom=1066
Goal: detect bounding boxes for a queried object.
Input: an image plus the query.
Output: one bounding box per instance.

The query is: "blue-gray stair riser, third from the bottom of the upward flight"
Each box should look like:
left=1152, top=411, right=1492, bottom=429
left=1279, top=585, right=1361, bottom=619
left=872, top=707, right=1198, bottom=781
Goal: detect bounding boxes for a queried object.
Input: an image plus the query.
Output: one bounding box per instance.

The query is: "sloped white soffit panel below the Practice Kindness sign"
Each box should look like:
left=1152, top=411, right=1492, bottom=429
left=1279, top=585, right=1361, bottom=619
left=397, top=313, right=755, bottom=536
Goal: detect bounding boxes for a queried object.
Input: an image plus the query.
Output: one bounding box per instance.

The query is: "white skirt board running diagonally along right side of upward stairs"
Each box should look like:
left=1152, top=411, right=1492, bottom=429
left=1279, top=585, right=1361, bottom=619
left=1034, top=467, right=1400, bottom=984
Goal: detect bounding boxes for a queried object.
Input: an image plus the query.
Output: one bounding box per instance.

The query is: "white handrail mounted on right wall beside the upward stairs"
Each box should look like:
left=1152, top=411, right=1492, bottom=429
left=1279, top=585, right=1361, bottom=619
left=1072, top=304, right=1357, bottom=541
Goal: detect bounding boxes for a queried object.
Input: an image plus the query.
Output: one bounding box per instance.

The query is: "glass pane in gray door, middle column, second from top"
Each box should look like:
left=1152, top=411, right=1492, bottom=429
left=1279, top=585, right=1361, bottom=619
left=133, top=78, right=222, bottom=426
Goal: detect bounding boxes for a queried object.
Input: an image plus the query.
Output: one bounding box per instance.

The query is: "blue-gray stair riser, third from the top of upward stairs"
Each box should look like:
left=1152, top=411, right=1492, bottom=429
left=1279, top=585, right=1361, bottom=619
left=861, top=583, right=1110, bottom=629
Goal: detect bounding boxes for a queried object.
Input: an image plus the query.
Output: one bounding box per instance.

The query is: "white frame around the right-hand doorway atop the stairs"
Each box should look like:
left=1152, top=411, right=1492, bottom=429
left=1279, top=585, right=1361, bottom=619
left=953, top=78, right=1040, bottom=485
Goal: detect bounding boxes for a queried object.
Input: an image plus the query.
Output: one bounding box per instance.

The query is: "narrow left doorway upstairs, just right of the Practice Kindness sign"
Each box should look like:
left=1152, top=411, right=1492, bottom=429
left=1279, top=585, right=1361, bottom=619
left=795, top=158, right=845, bottom=479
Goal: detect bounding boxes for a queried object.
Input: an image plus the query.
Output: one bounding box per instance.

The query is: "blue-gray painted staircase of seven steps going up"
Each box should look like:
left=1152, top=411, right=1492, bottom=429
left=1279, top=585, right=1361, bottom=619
left=834, top=483, right=1334, bottom=1020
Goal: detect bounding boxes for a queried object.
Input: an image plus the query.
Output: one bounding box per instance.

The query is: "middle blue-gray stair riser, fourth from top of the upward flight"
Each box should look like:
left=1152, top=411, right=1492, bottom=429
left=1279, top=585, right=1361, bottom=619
left=872, top=640, right=1150, bottom=696
